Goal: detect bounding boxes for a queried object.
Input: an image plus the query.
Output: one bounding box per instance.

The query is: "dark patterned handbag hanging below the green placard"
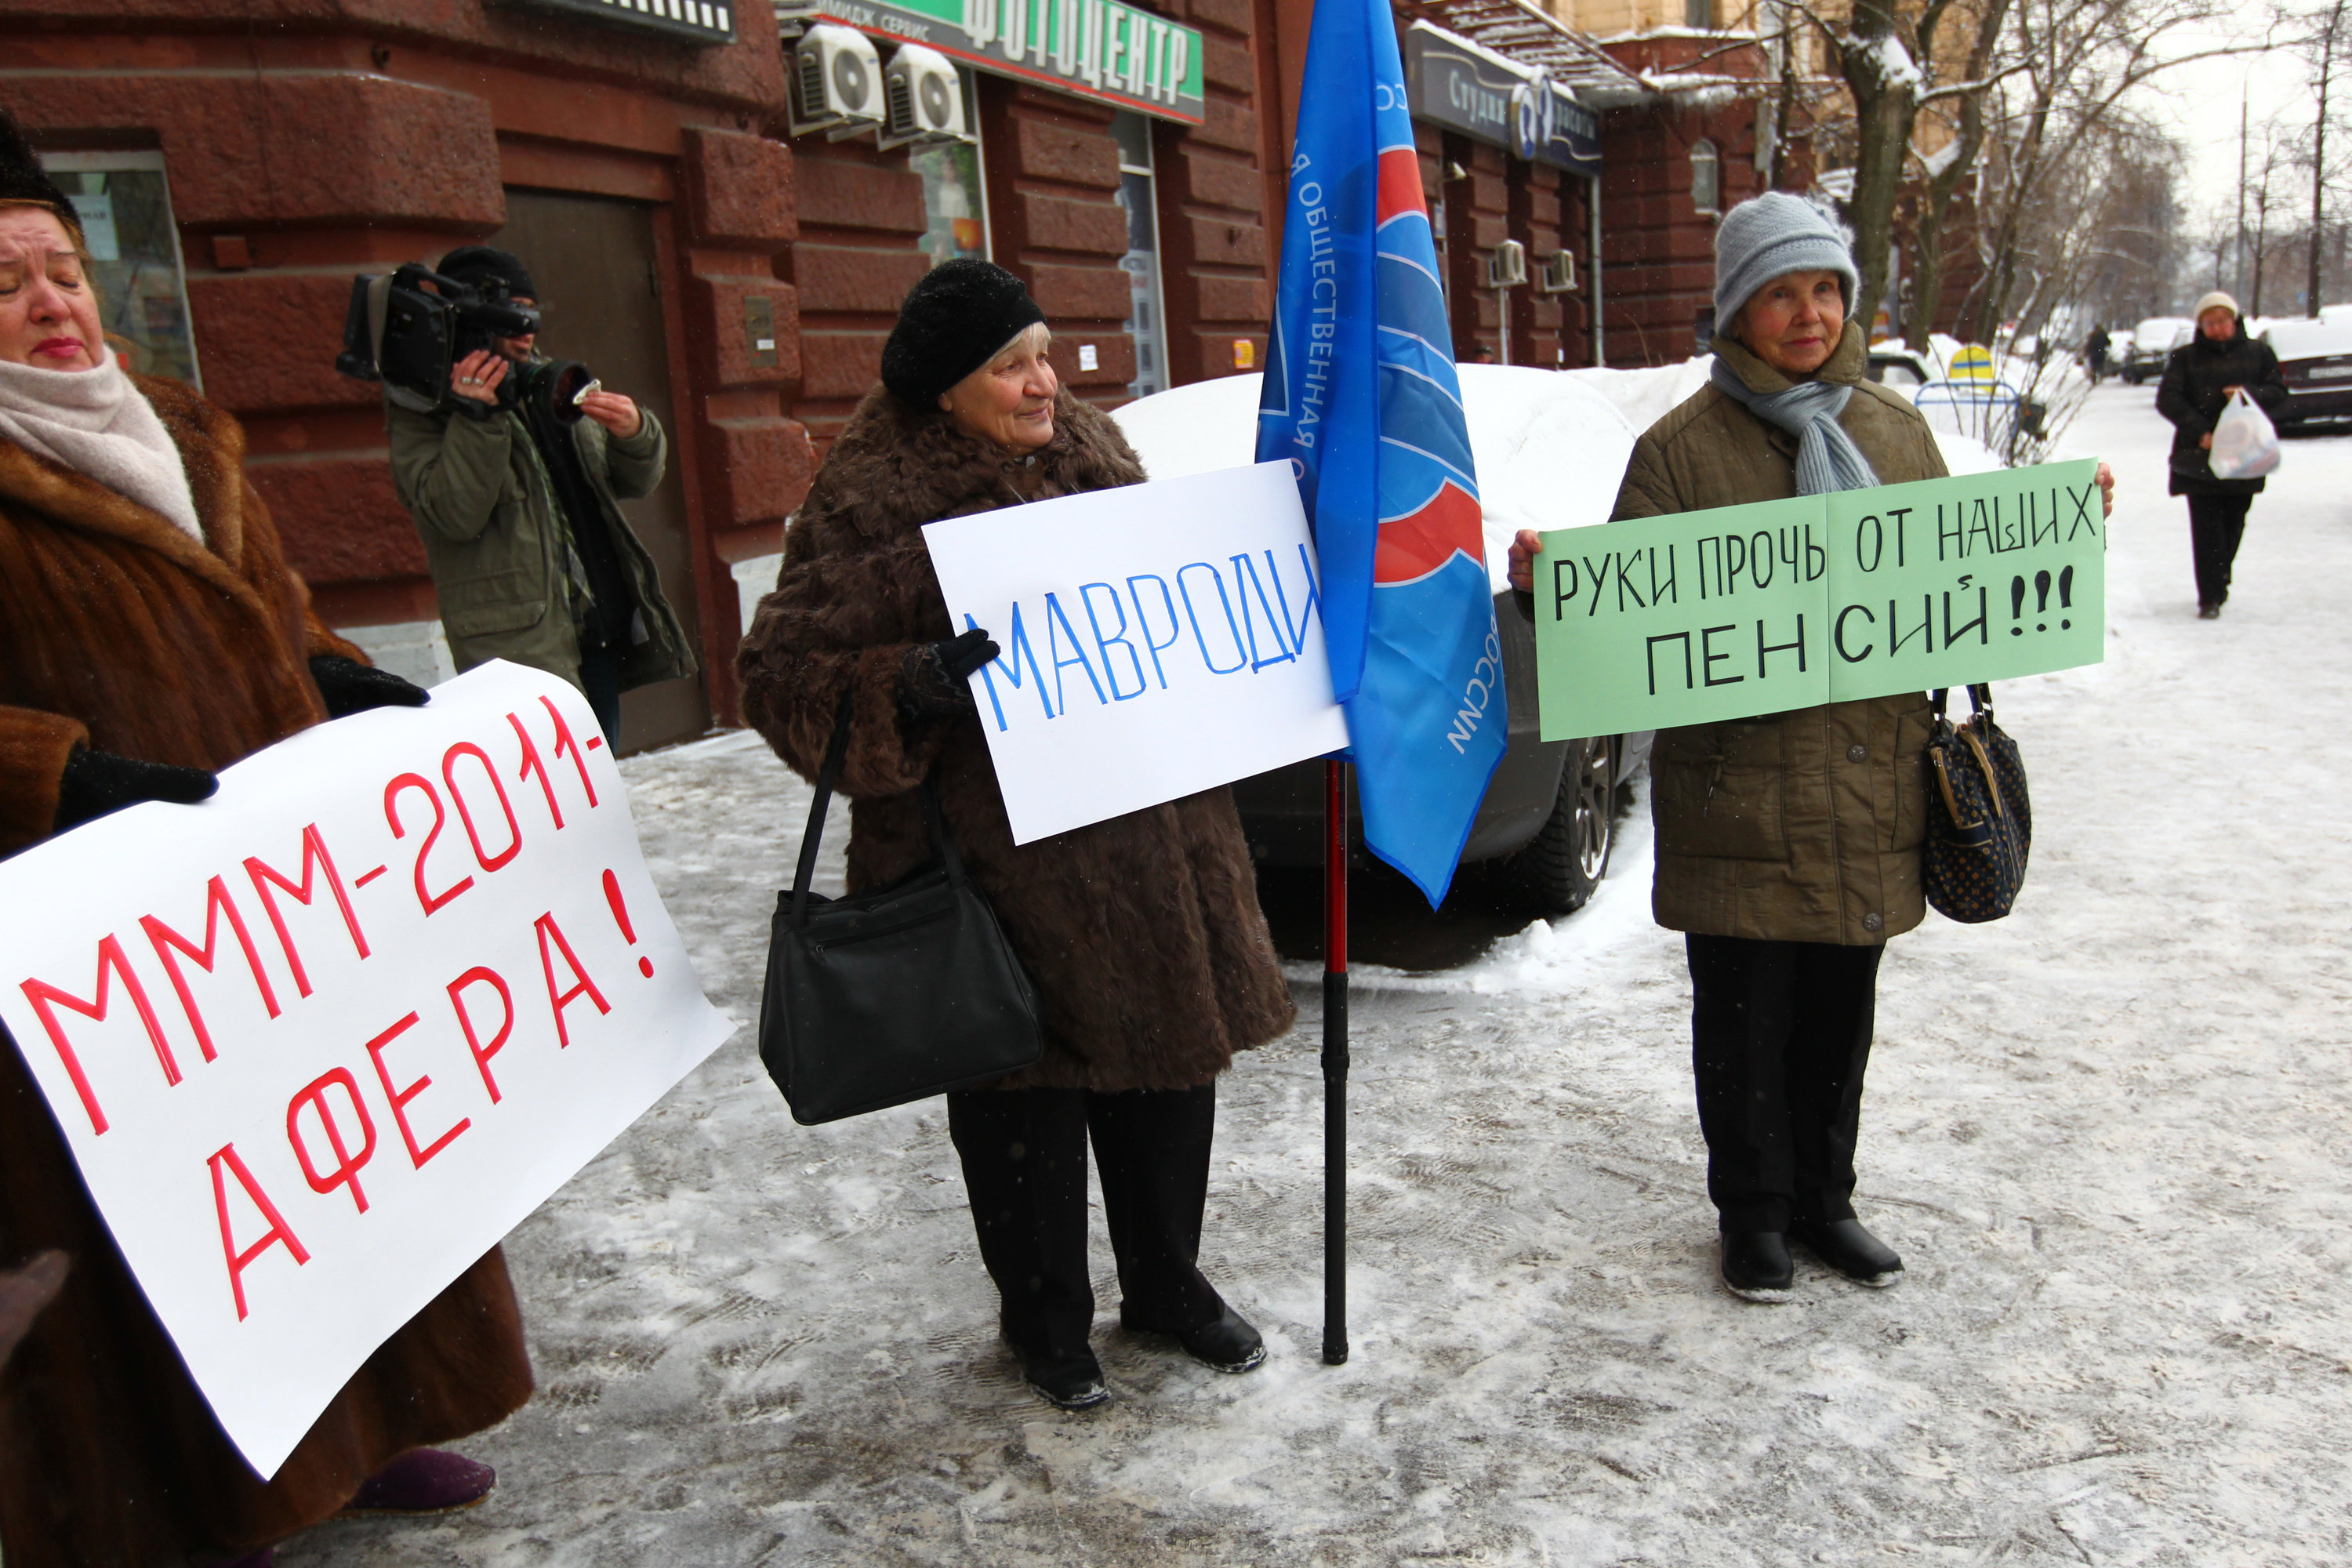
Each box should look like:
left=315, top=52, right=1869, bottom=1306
left=1924, top=687, right=2034, bottom=926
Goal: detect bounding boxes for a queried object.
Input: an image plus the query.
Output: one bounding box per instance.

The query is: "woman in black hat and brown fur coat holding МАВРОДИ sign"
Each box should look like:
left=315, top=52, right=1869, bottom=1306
left=739, top=259, right=1294, bottom=1408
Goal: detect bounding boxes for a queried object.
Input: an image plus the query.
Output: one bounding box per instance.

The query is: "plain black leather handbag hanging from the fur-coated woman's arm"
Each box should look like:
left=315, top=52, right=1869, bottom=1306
left=760, top=696, right=1044, bottom=1126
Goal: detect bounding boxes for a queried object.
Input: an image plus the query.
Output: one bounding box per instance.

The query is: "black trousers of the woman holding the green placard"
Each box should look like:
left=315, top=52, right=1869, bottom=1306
left=1684, top=935, right=1886, bottom=1229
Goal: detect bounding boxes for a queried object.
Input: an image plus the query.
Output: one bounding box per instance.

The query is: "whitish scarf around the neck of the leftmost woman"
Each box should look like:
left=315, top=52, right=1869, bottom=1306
left=0, top=355, right=205, bottom=543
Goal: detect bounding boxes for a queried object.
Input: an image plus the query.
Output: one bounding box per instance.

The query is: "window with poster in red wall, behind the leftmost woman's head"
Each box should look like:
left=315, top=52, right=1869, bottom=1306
left=40, top=151, right=202, bottom=388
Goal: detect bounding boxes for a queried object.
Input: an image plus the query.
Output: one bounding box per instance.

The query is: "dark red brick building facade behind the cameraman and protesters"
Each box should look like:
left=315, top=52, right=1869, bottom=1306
left=0, top=0, right=1778, bottom=746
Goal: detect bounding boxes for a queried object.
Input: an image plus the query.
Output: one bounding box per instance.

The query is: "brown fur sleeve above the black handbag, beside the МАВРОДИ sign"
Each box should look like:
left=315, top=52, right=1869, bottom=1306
left=736, top=496, right=946, bottom=797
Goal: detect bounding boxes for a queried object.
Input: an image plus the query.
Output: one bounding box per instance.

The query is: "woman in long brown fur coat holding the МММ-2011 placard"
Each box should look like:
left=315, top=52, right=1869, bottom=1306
left=0, top=115, right=532, bottom=1568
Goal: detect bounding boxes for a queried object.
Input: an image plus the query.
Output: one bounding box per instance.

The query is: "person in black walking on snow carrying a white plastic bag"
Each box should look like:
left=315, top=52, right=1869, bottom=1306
left=2157, top=289, right=2286, bottom=621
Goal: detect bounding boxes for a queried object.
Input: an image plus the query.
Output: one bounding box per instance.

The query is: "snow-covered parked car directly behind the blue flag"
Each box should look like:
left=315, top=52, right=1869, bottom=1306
left=1112, top=362, right=1656, bottom=914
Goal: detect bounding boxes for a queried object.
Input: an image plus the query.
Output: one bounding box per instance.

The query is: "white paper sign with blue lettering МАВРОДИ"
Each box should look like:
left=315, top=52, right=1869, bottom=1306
left=922, top=463, right=1348, bottom=844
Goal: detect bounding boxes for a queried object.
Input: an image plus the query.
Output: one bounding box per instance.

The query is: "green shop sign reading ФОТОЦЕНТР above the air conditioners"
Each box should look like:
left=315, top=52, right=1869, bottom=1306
left=818, top=0, right=1207, bottom=125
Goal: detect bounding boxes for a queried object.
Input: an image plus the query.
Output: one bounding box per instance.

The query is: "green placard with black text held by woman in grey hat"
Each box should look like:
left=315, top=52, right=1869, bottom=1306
left=1536, top=461, right=2107, bottom=741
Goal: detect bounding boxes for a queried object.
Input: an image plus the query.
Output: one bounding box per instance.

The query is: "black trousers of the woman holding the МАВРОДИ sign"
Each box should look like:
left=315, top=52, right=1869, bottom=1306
left=948, top=1083, right=1225, bottom=1356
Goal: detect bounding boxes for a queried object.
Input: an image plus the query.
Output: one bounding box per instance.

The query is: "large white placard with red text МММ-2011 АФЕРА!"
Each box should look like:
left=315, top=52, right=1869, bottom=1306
left=0, top=663, right=734, bottom=1476
